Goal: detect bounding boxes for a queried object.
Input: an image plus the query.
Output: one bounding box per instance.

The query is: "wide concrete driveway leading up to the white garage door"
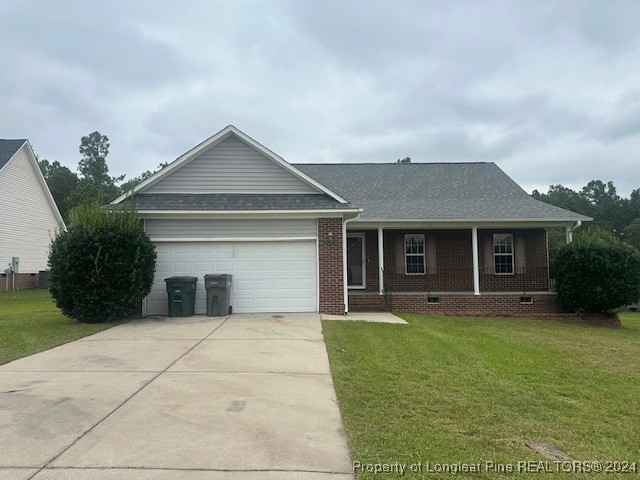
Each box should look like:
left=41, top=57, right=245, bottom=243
left=0, top=314, right=354, bottom=480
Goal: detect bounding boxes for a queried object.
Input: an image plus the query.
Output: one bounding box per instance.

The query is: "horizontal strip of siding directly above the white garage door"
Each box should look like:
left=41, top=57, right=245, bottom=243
left=144, top=219, right=318, bottom=240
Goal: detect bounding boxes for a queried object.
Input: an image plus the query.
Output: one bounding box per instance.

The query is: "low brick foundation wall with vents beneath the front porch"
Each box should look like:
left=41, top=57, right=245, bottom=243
left=349, top=293, right=561, bottom=317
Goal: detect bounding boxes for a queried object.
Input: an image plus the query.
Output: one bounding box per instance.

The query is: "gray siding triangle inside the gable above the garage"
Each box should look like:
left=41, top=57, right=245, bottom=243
left=145, top=135, right=320, bottom=194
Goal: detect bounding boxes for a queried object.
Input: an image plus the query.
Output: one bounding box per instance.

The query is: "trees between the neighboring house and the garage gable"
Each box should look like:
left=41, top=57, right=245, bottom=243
left=38, top=132, right=168, bottom=220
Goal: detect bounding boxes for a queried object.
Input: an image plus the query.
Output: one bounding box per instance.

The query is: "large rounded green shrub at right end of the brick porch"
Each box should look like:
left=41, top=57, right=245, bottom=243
left=554, top=230, right=640, bottom=313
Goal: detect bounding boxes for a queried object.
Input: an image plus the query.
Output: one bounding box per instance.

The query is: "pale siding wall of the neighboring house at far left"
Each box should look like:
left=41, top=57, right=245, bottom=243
left=0, top=144, right=60, bottom=273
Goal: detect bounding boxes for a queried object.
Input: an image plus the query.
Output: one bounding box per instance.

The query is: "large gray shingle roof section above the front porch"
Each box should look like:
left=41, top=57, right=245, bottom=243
left=294, top=163, right=589, bottom=221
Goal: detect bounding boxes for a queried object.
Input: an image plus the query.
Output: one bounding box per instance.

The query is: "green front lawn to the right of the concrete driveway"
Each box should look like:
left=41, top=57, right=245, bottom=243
left=323, top=313, right=640, bottom=479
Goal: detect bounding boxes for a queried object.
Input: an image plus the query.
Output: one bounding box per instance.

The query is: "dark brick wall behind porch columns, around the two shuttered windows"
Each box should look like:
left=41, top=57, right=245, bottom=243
left=349, top=228, right=549, bottom=292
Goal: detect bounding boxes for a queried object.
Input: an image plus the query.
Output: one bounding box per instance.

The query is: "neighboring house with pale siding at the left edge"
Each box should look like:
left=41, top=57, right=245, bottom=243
left=0, top=139, right=64, bottom=290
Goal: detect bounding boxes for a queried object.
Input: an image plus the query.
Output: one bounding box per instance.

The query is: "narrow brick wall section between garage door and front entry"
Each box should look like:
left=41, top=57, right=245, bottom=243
left=318, top=218, right=345, bottom=315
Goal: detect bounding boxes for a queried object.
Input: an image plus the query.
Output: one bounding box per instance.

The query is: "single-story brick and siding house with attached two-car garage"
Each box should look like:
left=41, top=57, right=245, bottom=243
left=113, top=126, right=590, bottom=315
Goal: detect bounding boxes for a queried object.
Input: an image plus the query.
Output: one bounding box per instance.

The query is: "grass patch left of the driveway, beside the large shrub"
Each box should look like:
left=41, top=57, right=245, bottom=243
left=0, top=290, right=114, bottom=365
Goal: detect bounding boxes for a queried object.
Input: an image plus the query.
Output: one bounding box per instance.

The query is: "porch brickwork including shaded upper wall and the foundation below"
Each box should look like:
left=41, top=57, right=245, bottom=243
left=349, top=228, right=560, bottom=316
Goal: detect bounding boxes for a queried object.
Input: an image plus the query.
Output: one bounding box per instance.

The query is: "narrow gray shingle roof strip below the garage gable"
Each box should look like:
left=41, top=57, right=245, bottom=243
left=123, top=193, right=353, bottom=211
